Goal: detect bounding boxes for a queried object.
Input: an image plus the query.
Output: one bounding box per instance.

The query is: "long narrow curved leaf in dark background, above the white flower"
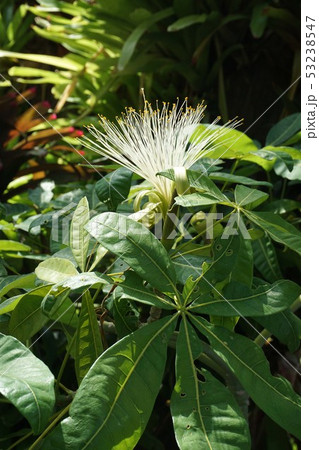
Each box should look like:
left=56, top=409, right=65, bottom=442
left=118, top=8, right=174, bottom=70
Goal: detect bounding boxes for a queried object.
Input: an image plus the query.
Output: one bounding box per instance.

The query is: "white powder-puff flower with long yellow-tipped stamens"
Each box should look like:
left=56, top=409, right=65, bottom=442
left=80, top=98, right=238, bottom=210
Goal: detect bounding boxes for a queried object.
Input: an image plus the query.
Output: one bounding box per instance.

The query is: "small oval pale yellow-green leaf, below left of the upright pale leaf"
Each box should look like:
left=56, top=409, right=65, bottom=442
left=35, top=257, right=79, bottom=283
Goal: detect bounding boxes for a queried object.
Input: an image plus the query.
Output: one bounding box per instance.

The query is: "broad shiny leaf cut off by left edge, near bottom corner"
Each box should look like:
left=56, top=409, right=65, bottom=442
left=0, top=333, right=55, bottom=434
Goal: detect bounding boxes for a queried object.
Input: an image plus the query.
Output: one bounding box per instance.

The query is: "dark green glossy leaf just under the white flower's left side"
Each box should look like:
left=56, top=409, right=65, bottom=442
left=95, top=167, right=133, bottom=211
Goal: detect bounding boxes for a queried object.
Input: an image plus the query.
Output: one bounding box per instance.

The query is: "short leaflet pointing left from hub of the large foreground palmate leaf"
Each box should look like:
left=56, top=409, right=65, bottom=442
left=116, top=272, right=175, bottom=309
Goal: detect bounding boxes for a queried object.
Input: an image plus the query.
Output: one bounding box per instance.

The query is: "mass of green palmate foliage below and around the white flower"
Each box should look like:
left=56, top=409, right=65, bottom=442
left=0, top=110, right=300, bottom=450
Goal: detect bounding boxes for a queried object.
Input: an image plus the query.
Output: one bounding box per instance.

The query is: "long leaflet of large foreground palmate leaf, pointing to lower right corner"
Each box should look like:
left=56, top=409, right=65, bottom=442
left=191, top=316, right=300, bottom=437
